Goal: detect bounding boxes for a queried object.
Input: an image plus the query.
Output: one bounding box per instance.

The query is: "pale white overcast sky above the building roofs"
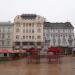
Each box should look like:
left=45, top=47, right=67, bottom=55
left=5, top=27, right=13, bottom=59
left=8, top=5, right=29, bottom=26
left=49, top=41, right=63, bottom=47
left=0, top=0, right=75, bottom=27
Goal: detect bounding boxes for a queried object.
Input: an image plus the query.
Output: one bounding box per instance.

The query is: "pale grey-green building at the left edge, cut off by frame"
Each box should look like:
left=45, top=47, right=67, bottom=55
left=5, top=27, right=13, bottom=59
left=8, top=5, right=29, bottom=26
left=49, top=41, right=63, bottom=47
left=0, top=22, right=13, bottom=49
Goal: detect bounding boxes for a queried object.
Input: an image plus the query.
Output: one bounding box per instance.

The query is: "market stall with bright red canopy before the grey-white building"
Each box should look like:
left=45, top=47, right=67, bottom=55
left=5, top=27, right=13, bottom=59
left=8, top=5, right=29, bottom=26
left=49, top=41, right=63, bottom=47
left=48, top=47, right=63, bottom=63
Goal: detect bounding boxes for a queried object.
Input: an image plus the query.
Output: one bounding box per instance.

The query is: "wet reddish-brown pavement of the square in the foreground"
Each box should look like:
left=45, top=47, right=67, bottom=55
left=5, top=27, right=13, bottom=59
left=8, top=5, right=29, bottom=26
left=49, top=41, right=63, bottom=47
left=0, top=56, right=75, bottom=75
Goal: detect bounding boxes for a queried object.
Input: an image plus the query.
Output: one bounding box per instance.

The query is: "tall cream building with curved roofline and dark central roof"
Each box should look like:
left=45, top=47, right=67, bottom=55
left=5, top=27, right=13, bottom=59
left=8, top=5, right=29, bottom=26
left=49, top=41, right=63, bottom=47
left=13, top=14, right=45, bottom=49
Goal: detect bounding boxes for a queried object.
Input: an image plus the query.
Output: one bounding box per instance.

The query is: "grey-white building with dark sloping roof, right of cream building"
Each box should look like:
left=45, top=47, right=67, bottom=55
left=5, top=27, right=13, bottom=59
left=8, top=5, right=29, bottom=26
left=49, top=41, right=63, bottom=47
left=44, top=22, right=74, bottom=48
